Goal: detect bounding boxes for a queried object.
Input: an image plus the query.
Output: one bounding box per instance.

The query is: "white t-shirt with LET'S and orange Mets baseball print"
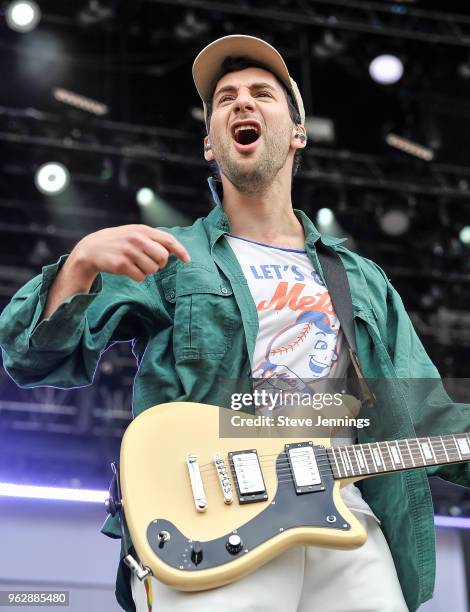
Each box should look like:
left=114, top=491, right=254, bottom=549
left=225, top=234, right=378, bottom=520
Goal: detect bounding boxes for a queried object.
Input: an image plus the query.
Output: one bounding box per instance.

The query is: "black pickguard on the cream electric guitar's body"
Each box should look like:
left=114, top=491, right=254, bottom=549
left=147, top=446, right=351, bottom=571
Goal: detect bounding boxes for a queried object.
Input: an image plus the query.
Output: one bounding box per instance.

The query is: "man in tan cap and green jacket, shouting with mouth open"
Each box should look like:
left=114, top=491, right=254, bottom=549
left=0, top=36, right=470, bottom=612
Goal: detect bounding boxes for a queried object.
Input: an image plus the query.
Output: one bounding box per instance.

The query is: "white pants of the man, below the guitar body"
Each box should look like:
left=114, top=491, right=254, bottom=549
left=132, top=513, right=408, bottom=612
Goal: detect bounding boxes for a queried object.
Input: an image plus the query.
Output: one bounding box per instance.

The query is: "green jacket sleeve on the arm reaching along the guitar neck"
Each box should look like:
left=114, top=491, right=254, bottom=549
left=370, top=267, right=470, bottom=486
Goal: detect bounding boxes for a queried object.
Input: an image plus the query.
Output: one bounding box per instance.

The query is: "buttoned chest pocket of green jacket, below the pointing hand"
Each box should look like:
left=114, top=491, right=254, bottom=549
left=162, top=266, right=241, bottom=361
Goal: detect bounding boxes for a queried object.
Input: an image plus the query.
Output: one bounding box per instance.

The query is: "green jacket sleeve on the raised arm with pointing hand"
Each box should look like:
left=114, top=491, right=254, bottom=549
left=0, top=256, right=166, bottom=388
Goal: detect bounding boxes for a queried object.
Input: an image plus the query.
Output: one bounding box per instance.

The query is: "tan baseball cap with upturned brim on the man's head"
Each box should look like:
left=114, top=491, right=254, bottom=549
left=193, top=34, right=305, bottom=131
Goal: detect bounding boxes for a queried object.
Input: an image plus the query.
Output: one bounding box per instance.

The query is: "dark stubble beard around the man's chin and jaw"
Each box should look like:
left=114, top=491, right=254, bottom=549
left=211, top=126, right=292, bottom=195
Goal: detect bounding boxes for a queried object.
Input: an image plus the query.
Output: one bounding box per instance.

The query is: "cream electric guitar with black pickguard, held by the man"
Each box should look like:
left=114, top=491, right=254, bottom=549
left=120, top=402, right=470, bottom=591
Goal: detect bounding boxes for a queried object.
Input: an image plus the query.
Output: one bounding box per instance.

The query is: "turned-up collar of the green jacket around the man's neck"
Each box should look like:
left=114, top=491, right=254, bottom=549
left=204, top=177, right=347, bottom=251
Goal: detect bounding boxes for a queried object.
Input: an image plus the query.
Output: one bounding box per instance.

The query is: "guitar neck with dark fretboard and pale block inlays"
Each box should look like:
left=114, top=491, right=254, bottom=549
left=327, top=433, right=470, bottom=479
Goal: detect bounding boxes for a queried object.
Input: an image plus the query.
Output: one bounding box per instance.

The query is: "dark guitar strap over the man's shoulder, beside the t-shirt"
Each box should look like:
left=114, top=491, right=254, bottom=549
left=315, top=240, right=375, bottom=406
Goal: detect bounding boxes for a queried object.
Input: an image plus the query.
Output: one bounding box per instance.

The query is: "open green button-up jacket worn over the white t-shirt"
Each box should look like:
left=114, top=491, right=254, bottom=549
left=0, top=175, right=470, bottom=610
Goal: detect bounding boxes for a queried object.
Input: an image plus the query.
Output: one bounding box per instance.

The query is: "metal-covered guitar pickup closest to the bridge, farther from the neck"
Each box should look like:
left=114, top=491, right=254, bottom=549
left=228, top=449, right=268, bottom=504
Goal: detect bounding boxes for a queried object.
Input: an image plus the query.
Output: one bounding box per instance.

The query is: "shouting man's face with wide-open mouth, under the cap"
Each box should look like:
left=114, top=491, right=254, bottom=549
left=206, top=68, right=294, bottom=193
